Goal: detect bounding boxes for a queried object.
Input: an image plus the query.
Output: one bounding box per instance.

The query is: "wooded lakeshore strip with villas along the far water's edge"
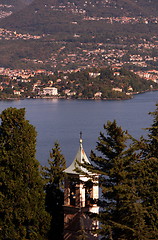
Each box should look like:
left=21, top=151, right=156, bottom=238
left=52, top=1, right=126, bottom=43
left=0, top=67, right=158, bottom=99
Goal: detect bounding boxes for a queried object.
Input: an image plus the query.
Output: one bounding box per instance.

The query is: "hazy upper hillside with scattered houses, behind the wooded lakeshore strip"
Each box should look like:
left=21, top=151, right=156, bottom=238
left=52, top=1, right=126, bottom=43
left=0, top=0, right=158, bottom=71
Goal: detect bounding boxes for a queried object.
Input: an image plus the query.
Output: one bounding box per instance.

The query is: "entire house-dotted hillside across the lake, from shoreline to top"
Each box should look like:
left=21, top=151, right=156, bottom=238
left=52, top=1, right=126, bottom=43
left=0, top=0, right=158, bottom=99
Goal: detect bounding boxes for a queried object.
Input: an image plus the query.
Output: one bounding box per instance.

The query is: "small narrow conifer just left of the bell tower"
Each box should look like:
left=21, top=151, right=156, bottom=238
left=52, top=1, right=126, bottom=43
left=43, top=142, right=66, bottom=240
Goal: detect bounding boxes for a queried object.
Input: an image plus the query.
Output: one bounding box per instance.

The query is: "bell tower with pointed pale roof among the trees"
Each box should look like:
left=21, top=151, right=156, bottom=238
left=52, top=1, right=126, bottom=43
left=64, top=133, right=99, bottom=240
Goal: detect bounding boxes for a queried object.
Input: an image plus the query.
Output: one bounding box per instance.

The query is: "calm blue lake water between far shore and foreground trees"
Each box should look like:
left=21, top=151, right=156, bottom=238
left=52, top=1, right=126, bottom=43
left=0, top=91, right=158, bottom=165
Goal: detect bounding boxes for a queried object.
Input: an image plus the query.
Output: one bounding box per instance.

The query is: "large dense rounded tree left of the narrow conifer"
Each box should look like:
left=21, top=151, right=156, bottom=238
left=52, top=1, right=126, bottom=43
left=0, top=108, right=49, bottom=240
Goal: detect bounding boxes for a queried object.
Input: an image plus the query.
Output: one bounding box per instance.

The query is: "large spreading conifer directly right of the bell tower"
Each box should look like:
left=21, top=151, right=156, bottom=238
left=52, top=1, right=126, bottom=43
left=90, top=121, right=148, bottom=240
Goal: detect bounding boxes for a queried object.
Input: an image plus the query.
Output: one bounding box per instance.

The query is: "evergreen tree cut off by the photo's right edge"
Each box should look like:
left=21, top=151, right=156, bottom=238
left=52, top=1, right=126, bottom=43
left=138, top=105, right=158, bottom=239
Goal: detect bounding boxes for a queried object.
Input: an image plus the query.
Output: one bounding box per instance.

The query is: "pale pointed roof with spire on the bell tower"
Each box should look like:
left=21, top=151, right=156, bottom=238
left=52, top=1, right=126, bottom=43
left=64, top=133, right=91, bottom=174
